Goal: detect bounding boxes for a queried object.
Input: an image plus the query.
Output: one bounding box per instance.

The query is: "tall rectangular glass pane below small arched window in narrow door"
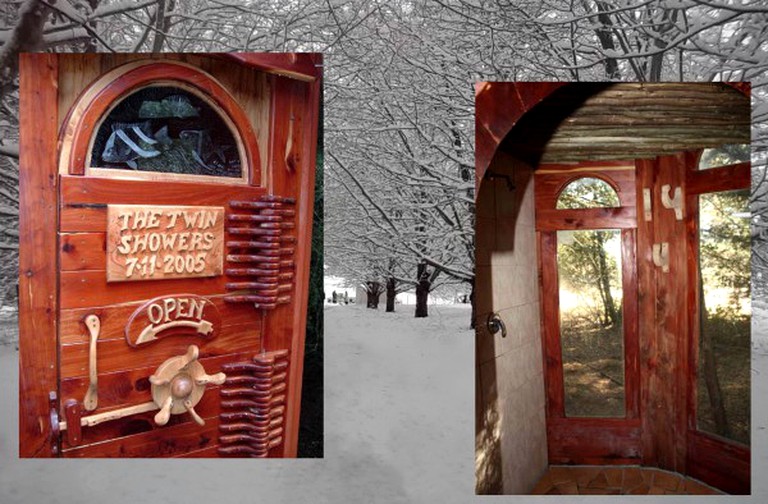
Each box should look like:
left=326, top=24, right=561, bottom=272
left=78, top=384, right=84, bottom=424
left=557, top=229, right=625, bottom=417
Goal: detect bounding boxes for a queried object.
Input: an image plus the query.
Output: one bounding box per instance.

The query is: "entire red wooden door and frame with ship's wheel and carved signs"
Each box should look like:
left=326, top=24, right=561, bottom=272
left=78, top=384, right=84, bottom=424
left=20, top=55, right=319, bottom=457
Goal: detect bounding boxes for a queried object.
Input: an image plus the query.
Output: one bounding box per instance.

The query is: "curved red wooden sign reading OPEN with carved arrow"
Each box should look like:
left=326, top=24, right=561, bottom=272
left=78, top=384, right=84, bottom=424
left=125, top=294, right=221, bottom=347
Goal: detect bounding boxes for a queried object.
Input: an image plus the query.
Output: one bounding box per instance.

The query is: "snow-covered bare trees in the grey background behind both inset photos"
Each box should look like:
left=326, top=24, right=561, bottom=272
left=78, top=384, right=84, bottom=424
left=0, top=0, right=768, bottom=322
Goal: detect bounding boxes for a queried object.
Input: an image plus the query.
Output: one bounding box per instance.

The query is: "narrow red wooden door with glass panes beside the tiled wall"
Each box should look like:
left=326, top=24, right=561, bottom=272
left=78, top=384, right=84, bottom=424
left=535, top=161, right=641, bottom=464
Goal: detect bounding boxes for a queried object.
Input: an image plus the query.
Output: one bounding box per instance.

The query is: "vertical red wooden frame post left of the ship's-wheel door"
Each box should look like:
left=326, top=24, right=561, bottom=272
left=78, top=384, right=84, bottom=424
left=19, top=54, right=58, bottom=457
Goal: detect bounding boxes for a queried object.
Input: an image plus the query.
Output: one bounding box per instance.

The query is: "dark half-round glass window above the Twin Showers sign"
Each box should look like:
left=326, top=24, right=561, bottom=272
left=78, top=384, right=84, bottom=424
left=91, top=86, right=242, bottom=178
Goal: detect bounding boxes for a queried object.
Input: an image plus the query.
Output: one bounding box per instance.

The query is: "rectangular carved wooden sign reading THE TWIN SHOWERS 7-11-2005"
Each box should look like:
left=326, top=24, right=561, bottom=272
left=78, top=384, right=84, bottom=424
left=107, top=205, right=224, bottom=282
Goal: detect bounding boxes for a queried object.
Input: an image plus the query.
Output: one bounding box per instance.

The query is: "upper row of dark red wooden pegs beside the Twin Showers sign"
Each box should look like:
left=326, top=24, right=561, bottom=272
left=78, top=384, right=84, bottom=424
left=224, top=195, right=296, bottom=309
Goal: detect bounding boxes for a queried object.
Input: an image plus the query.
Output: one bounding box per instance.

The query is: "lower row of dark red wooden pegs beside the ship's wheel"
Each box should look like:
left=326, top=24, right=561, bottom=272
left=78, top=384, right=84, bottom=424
left=219, top=350, right=288, bottom=458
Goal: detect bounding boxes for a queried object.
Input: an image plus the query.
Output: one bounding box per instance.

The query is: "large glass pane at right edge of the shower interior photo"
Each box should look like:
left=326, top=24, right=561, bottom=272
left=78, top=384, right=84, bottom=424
left=696, top=190, right=752, bottom=444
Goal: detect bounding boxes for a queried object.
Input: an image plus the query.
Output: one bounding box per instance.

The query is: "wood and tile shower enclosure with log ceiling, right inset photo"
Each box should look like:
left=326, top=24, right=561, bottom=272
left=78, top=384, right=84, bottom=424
left=475, top=82, right=751, bottom=494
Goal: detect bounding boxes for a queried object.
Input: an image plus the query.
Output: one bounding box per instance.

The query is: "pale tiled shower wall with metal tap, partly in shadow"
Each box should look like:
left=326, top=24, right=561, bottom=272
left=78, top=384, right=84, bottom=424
left=475, top=154, right=547, bottom=494
